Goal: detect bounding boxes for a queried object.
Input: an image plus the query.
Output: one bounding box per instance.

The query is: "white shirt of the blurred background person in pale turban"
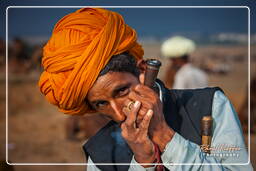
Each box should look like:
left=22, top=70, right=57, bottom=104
left=173, top=64, right=208, bottom=89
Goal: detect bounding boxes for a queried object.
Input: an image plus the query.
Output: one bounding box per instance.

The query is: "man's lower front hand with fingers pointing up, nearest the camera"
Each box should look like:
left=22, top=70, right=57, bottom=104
left=121, top=101, right=155, bottom=167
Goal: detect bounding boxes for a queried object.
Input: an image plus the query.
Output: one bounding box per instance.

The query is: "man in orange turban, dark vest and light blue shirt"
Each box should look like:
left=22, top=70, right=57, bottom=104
left=39, top=8, right=252, bottom=171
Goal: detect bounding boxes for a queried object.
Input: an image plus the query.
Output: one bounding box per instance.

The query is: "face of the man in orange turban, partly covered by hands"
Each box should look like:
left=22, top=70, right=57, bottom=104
left=87, top=72, right=140, bottom=122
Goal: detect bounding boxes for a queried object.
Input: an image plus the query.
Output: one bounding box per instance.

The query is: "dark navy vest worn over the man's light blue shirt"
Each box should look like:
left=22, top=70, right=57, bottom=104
left=83, top=81, right=221, bottom=171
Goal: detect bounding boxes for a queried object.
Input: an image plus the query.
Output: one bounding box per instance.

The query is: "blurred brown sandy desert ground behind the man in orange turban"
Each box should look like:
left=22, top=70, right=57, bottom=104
left=0, top=44, right=256, bottom=171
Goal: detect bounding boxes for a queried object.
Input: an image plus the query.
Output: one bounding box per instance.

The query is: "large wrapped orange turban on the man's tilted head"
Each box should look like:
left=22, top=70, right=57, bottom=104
left=39, top=8, right=143, bottom=114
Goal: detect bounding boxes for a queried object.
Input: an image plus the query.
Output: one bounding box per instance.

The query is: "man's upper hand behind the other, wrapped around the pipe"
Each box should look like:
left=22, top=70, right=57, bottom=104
left=128, top=84, right=174, bottom=151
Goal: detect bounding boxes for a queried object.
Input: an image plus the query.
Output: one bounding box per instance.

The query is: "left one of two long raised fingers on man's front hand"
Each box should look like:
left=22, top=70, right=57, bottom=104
left=125, top=101, right=141, bottom=127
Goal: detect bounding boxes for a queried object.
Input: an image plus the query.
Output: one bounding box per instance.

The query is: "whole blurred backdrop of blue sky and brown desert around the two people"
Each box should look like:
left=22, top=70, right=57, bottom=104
left=0, top=1, right=256, bottom=171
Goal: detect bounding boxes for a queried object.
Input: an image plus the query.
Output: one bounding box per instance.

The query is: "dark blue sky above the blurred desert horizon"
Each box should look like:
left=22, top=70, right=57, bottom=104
left=0, top=0, right=256, bottom=38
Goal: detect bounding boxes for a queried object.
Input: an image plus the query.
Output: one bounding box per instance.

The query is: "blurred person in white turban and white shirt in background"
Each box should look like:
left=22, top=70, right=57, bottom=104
left=161, top=36, right=208, bottom=89
